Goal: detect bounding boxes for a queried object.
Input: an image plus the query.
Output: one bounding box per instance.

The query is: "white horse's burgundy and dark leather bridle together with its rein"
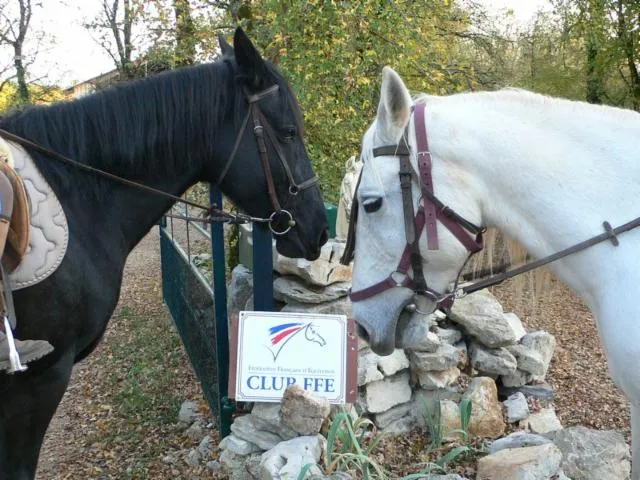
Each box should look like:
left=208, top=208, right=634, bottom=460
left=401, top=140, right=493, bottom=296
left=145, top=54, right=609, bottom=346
left=340, top=104, right=640, bottom=311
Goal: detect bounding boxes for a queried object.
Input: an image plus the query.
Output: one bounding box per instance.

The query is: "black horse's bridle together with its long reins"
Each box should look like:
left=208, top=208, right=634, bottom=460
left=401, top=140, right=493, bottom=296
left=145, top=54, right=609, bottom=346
left=0, top=85, right=318, bottom=236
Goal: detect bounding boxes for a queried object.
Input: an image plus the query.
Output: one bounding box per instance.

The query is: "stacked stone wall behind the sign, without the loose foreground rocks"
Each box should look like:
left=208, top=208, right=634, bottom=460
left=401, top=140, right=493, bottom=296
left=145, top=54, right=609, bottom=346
left=229, top=240, right=555, bottom=438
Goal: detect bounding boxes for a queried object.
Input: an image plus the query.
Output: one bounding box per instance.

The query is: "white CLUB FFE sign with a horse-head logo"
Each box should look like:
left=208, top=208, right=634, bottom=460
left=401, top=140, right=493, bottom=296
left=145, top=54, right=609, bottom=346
left=235, top=311, right=347, bottom=404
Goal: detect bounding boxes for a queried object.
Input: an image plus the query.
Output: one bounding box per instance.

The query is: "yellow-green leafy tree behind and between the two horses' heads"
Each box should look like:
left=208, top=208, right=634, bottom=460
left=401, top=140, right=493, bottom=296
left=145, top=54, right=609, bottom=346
left=220, top=0, right=478, bottom=200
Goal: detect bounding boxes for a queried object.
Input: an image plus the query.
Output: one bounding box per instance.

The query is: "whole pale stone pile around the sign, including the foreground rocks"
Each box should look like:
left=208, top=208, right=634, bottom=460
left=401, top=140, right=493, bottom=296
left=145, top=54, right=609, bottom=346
left=221, top=239, right=629, bottom=480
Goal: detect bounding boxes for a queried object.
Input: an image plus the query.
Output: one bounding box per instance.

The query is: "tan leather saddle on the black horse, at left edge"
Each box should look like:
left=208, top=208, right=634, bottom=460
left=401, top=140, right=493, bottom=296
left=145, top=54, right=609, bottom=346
left=0, top=138, right=31, bottom=273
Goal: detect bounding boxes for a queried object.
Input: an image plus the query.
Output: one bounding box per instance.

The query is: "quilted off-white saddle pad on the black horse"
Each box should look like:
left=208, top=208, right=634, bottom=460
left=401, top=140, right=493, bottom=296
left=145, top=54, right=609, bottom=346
left=0, top=139, right=69, bottom=290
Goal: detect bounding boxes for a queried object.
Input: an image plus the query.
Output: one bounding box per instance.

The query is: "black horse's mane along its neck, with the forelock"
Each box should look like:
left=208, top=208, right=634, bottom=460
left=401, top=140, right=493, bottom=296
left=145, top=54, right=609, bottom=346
left=0, top=59, right=302, bottom=189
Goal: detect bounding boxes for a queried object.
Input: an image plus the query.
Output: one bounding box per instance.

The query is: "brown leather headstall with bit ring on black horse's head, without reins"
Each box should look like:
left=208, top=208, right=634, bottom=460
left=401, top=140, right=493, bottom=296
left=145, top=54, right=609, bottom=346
left=215, top=85, right=318, bottom=235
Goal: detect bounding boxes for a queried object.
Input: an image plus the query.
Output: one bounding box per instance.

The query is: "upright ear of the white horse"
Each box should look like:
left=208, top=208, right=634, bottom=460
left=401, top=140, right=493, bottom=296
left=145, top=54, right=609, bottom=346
left=377, top=67, right=411, bottom=140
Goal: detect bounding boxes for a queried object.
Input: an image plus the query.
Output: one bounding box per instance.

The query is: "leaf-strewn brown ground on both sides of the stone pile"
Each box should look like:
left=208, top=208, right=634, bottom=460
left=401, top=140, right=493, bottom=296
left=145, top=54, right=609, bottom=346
left=37, top=229, right=630, bottom=480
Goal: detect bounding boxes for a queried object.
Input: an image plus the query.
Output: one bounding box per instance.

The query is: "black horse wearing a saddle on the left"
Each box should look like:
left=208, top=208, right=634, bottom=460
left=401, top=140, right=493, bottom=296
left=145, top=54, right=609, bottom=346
left=0, top=29, right=328, bottom=480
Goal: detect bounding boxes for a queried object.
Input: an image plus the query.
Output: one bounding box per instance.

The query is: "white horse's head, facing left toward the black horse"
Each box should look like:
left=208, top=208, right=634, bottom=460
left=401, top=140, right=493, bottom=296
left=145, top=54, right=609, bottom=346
left=352, top=67, right=481, bottom=355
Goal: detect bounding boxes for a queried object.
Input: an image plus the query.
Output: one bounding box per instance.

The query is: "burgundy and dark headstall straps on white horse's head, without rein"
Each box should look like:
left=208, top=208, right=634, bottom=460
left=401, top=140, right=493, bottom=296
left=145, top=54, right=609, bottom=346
left=340, top=103, right=485, bottom=309
